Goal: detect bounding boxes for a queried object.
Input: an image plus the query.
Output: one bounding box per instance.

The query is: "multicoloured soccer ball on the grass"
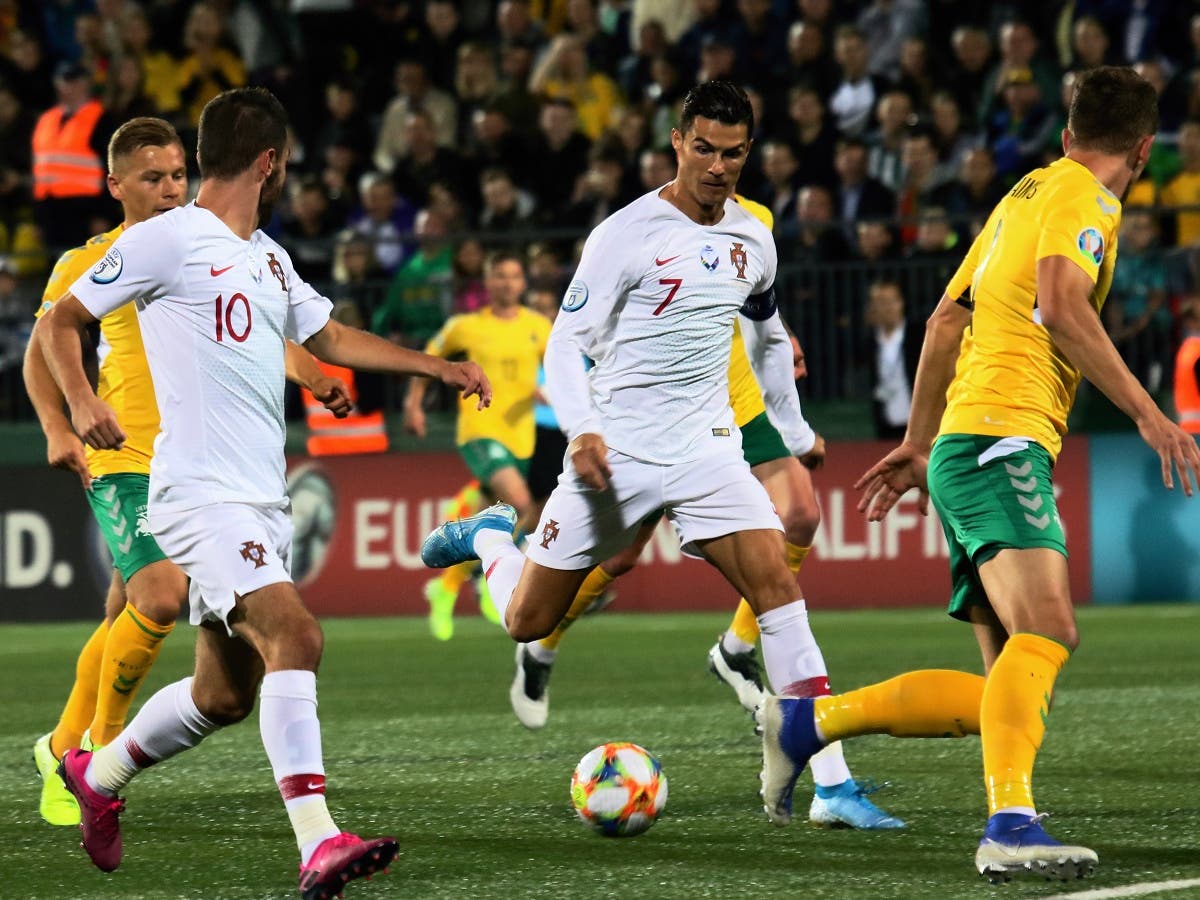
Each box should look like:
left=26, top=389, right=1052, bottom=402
left=571, top=742, right=667, bottom=838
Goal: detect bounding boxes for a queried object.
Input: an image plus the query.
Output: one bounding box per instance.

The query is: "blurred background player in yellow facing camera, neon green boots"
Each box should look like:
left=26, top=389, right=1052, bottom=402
left=404, top=251, right=551, bottom=641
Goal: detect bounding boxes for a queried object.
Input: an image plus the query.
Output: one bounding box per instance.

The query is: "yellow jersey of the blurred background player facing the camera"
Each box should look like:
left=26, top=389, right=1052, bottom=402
left=425, top=306, right=551, bottom=460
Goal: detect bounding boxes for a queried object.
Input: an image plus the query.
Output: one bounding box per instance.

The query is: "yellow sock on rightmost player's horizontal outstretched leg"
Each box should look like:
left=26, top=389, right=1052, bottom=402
left=814, top=668, right=984, bottom=743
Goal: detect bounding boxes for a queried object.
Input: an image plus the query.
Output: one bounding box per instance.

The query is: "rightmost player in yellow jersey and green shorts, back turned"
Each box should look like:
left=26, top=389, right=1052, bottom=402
left=761, top=66, right=1200, bottom=880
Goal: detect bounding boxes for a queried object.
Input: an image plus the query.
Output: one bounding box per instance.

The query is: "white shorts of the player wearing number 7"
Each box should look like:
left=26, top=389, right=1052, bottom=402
left=526, top=446, right=784, bottom=570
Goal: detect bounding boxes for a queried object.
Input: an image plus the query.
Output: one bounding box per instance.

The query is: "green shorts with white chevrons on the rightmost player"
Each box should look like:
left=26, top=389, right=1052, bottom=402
left=929, top=434, right=1067, bottom=622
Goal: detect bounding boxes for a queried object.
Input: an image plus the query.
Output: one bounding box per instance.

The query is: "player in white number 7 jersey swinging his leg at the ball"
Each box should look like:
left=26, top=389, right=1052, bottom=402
left=422, top=82, right=854, bottom=801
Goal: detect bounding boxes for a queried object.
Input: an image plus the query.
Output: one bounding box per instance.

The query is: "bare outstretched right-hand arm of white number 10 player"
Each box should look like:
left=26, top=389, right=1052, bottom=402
left=304, top=319, right=492, bottom=409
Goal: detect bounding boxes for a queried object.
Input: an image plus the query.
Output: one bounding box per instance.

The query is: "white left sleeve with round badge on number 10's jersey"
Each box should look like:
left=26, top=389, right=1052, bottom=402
left=70, top=216, right=187, bottom=319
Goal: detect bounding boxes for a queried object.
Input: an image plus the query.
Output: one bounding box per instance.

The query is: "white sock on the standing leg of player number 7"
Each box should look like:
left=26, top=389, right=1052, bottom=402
left=758, top=607, right=851, bottom=787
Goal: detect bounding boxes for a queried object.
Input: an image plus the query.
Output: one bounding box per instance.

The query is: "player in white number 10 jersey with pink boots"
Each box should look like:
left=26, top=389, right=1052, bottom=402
left=37, top=89, right=491, bottom=900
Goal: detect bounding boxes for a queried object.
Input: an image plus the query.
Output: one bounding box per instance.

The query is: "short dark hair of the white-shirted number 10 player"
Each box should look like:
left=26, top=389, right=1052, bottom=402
left=196, top=88, right=288, bottom=178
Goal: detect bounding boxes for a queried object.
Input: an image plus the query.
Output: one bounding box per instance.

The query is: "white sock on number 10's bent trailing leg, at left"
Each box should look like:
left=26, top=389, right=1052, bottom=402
left=84, top=677, right=218, bottom=794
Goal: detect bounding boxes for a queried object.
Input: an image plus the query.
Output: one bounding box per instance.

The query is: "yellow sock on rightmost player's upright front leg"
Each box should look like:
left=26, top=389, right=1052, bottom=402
left=979, top=634, right=1070, bottom=814
